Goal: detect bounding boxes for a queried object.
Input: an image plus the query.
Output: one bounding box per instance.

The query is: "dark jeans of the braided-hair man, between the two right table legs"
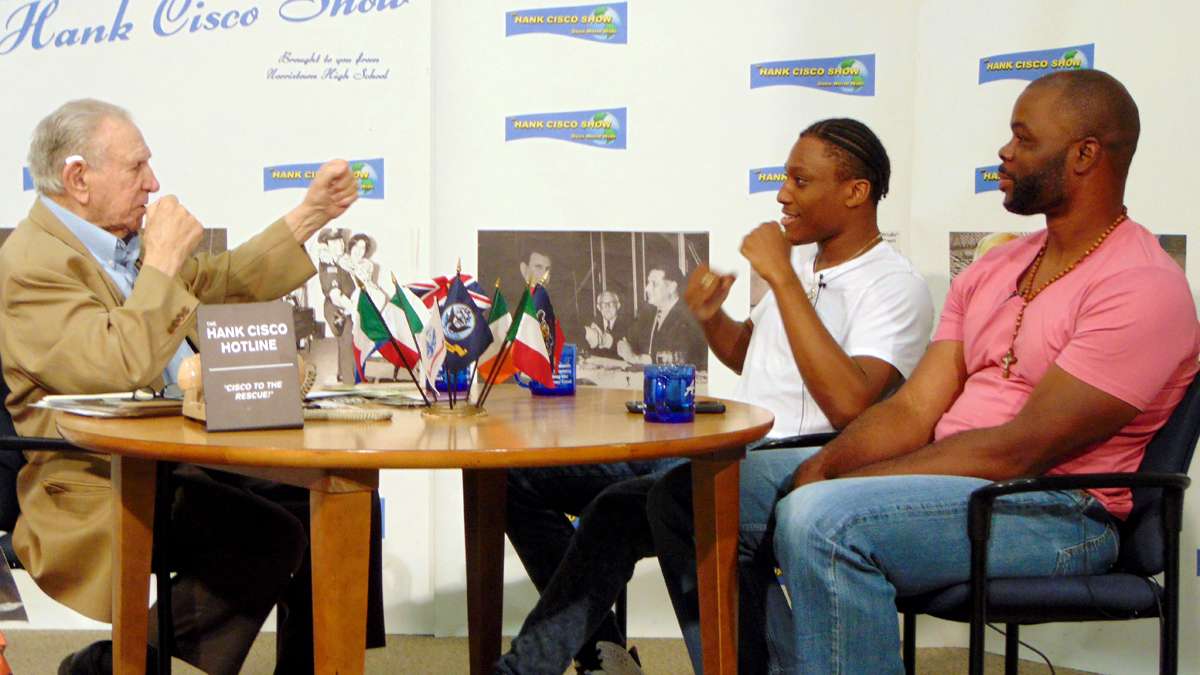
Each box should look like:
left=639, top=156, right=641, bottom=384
left=496, top=459, right=685, bottom=675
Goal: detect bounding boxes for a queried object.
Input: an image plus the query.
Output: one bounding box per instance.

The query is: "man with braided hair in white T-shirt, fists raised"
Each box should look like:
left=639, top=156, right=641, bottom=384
left=498, top=119, right=932, bottom=675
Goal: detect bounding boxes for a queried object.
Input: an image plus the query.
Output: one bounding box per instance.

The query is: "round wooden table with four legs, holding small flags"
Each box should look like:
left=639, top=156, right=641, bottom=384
left=58, top=386, right=773, bottom=674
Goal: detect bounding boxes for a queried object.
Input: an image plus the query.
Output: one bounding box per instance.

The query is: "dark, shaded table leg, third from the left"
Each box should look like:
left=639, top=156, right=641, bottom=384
left=462, top=468, right=508, bottom=675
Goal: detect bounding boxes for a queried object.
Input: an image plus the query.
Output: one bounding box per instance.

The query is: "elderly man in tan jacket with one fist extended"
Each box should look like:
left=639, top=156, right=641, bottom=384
left=0, top=100, right=358, bottom=673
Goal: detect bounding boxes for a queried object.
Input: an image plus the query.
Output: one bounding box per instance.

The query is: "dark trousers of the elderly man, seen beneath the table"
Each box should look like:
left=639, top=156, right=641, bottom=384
left=151, top=465, right=383, bottom=675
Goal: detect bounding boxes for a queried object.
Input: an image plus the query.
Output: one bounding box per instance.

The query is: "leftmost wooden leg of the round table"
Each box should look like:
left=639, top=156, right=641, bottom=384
left=112, top=455, right=158, bottom=675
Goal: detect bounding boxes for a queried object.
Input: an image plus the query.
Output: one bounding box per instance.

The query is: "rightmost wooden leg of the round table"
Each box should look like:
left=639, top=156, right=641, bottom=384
left=691, top=453, right=744, bottom=675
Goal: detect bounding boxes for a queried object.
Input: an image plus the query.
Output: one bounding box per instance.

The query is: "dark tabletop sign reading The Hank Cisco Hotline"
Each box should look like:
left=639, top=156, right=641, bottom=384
left=196, top=301, right=304, bottom=431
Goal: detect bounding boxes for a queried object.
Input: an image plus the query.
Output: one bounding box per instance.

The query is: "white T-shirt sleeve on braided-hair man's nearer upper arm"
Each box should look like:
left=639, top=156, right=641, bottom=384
left=845, top=273, right=934, bottom=380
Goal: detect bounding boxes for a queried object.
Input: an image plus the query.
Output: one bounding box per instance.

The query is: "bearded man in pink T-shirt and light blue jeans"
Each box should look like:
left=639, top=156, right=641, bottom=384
left=650, top=71, right=1200, bottom=674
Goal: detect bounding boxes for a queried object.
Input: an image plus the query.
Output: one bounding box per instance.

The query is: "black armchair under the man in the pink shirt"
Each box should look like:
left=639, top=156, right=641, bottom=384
left=896, top=369, right=1200, bottom=675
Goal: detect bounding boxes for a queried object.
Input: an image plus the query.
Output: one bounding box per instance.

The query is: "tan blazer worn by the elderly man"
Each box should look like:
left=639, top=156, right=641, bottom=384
left=0, top=199, right=317, bottom=622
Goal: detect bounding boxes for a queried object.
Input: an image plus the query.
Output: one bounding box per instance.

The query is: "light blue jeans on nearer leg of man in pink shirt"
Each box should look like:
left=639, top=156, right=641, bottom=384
left=774, top=476, right=1118, bottom=675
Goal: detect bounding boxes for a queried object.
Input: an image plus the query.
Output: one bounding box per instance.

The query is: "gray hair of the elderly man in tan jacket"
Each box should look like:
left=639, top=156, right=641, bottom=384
left=29, top=98, right=133, bottom=195
